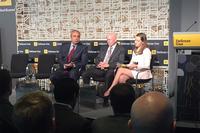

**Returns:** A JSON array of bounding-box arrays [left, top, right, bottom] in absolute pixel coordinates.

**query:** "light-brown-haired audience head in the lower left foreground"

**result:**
[[13, 91, 53, 133]]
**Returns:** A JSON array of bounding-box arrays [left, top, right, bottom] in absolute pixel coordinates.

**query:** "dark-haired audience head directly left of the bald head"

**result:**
[[110, 83, 135, 115]]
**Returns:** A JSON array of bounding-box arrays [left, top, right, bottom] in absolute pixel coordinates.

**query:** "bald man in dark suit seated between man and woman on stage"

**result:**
[[82, 33, 125, 105]]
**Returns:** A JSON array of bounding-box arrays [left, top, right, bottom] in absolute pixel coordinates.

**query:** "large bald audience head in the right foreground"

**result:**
[[129, 92, 174, 133]]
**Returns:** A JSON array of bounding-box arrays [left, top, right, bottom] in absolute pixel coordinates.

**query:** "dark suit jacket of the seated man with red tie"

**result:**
[[59, 42, 88, 70]]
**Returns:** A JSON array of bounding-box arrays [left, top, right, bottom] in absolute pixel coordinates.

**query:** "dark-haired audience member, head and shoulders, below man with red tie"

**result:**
[[53, 76, 91, 133]]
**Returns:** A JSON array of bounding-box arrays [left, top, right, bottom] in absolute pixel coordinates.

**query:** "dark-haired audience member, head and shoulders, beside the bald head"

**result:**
[[92, 83, 135, 133]]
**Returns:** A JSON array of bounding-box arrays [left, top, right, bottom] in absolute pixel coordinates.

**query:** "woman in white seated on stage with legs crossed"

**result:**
[[104, 33, 152, 96]]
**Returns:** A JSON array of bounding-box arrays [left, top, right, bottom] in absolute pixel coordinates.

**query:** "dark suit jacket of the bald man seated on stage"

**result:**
[[95, 44, 125, 69]]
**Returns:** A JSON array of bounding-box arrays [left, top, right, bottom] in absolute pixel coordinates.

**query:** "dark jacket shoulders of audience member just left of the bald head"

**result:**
[[91, 115, 131, 133]]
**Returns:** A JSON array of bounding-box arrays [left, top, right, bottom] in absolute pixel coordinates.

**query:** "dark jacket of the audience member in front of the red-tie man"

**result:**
[[54, 104, 91, 133]]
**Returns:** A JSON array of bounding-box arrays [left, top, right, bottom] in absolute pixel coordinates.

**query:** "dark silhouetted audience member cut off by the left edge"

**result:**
[[0, 69, 17, 133]]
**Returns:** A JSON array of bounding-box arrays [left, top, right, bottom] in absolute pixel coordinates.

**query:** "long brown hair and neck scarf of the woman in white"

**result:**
[[133, 33, 148, 55]]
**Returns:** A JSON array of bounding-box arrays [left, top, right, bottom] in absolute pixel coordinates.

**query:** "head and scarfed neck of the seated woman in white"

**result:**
[[135, 33, 148, 54]]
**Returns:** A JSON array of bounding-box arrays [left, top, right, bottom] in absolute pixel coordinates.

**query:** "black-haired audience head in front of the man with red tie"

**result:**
[[53, 76, 79, 108]]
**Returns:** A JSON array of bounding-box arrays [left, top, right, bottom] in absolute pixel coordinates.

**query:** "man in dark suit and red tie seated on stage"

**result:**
[[51, 30, 88, 80]]
